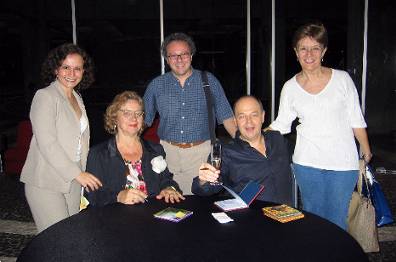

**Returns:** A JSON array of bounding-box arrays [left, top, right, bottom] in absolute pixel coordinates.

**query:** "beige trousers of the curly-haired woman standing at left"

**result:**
[[25, 180, 81, 233]]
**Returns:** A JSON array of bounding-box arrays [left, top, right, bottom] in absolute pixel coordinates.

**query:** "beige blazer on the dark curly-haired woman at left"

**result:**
[[20, 80, 89, 193]]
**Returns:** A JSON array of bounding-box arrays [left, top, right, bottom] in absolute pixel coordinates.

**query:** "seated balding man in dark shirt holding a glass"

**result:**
[[191, 96, 292, 205]]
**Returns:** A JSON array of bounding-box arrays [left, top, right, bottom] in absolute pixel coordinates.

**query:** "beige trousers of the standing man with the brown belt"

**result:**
[[160, 140, 210, 195]]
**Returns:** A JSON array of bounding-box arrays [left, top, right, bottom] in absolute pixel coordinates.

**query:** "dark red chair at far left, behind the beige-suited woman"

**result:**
[[4, 120, 33, 174]]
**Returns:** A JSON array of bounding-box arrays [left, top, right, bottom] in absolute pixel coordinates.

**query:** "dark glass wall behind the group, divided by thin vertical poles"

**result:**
[[0, 0, 396, 143]]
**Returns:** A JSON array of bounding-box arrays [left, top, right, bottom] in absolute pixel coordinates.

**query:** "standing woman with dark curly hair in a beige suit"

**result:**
[[21, 44, 102, 232]]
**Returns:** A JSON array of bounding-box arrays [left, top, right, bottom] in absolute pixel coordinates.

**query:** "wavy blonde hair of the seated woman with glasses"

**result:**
[[104, 91, 145, 135]]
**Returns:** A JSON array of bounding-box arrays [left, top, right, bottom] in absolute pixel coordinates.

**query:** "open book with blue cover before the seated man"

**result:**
[[214, 181, 264, 211]]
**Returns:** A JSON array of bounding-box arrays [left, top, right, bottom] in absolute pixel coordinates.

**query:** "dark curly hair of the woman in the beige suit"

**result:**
[[41, 43, 95, 90]]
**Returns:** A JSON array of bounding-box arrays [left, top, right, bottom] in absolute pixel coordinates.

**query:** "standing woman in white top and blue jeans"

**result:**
[[270, 23, 372, 229]]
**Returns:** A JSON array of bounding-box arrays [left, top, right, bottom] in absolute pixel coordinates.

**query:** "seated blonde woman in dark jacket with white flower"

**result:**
[[85, 91, 184, 206]]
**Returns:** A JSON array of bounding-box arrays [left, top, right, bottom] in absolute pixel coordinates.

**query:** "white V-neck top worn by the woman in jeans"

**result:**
[[271, 69, 367, 171]]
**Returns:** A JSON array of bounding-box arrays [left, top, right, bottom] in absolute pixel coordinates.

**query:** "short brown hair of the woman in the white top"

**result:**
[[292, 22, 328, 48]]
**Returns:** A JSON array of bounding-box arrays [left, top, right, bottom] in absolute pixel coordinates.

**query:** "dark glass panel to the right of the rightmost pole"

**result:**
[[366, 0, 396, 137]]
